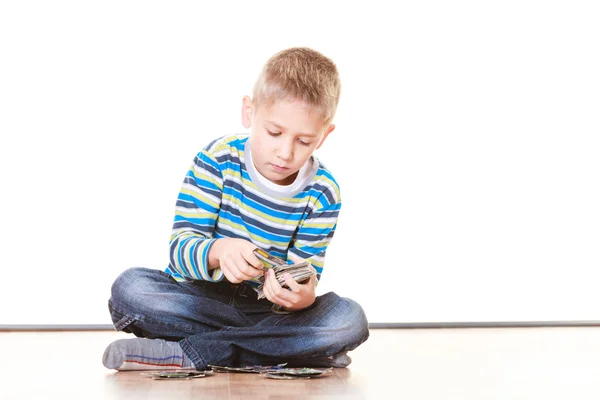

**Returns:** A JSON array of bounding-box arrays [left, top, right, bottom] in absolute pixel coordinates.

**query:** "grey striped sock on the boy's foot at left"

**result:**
[[102, 338, 194, 371]]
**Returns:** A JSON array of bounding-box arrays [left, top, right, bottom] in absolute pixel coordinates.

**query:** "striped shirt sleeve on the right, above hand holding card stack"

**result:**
[[288, 197, 342, 283]]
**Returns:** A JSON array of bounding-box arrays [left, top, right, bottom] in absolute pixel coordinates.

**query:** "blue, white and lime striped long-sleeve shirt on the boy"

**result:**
[[166, 135, 341, 282]]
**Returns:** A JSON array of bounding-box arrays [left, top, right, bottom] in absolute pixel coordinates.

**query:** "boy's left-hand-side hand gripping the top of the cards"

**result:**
[[208, 238, 264, 283]]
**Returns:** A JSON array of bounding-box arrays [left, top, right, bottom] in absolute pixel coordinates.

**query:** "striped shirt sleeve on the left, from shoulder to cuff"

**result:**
[[169, 150, 223, 282]]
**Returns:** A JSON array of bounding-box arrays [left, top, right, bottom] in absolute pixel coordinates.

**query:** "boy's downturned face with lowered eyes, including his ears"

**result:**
[[242, 97, 335, 185]]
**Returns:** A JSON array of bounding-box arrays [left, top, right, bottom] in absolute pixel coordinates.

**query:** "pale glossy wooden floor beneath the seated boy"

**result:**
[[0, 328, 600, 400]]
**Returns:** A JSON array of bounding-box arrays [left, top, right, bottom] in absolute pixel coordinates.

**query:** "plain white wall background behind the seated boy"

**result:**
[[0, 0, 600, 324]]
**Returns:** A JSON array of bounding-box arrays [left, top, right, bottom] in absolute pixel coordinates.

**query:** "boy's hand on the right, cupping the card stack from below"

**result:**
[[263, 255, 317, 311]]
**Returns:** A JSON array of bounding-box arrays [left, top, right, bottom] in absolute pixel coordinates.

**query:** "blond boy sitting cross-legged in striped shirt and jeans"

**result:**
[[103, 48, 369, 370]]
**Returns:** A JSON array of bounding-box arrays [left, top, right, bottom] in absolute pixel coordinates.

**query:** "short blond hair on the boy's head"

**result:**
[[252, 47, 341, 124]]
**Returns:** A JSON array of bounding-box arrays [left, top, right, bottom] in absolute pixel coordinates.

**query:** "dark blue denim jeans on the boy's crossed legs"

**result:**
[[108, 268, 369, 370]]
